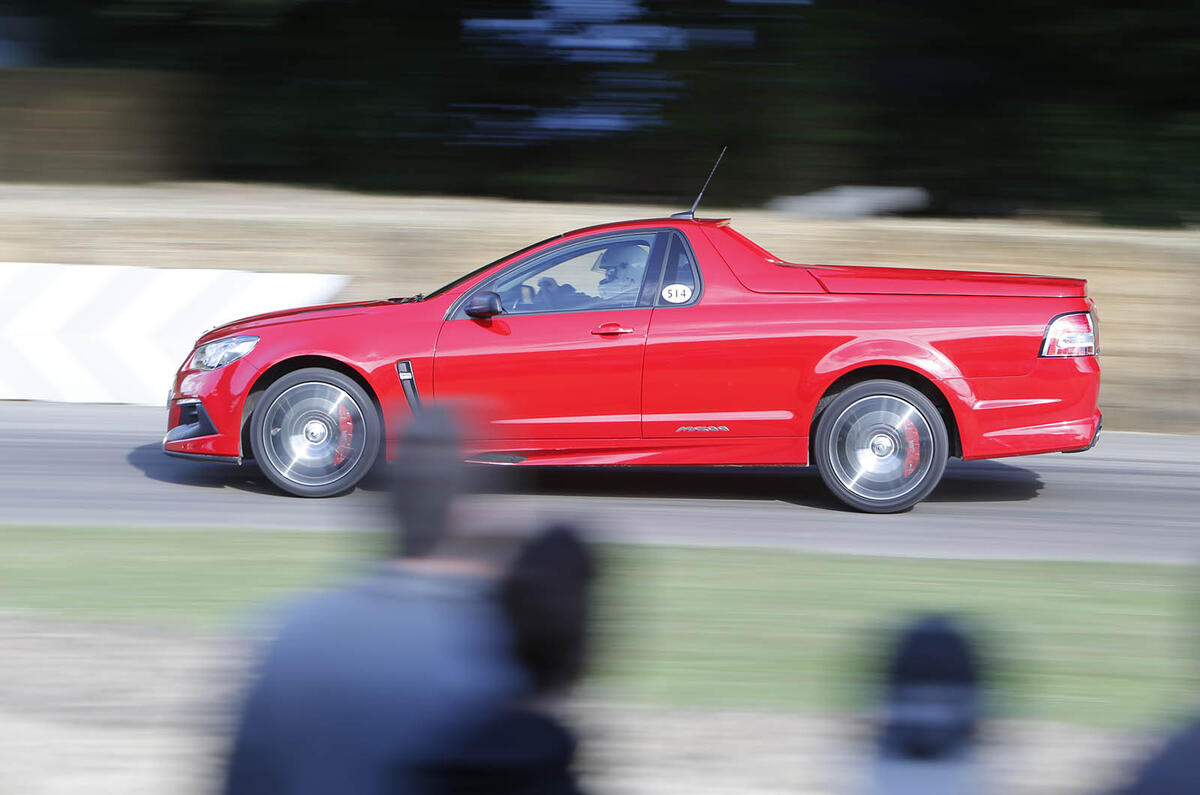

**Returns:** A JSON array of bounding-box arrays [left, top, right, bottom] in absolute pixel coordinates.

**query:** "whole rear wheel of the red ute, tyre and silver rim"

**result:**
[[812, 381, 950, 514]]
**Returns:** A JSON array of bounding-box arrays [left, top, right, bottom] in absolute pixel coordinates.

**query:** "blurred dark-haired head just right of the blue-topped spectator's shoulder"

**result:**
[[499, 525, 595, 694]]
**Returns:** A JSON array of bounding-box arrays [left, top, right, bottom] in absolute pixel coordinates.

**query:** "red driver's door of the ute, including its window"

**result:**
[[433, 229, 666, 442]]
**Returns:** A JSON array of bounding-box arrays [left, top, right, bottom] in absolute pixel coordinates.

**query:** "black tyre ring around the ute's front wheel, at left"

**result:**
[[250, 367, 383, 497]]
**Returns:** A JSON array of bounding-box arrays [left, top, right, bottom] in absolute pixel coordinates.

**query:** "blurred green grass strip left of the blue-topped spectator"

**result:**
[[0, 527, 377, 629]]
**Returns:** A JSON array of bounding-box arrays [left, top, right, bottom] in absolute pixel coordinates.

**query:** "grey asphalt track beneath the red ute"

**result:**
[[7, 401, 1200, 563]]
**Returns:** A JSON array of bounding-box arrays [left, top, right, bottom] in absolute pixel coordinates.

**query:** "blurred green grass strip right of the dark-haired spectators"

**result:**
[[592, 548, 1200, 725]]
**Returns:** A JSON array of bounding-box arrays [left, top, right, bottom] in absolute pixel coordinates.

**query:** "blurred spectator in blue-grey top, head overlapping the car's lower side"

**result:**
[[224, 407, 527, 795]]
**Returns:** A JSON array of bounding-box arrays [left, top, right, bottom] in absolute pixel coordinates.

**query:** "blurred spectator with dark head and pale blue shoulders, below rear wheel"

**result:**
[[866, 616, 985, 795]]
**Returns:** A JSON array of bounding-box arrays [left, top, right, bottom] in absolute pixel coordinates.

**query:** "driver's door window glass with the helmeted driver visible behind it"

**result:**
[[486, 232, 656, 315]]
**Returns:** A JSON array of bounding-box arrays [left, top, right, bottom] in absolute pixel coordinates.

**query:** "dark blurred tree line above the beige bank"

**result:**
[[0, 0, 1200, 227]]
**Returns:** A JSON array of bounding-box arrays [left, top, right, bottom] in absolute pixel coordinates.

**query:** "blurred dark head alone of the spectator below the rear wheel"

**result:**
[[881, 616, 983, 760]]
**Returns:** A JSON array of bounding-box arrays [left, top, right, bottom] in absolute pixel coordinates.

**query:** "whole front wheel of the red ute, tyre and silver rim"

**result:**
[[250, 367, 383, 497]]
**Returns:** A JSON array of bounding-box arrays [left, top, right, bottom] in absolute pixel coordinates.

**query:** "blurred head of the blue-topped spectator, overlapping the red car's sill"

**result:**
[[391, 406, 466, 557]]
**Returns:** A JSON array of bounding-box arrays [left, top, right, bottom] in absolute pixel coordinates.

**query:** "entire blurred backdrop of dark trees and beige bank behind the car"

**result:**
[[0, 0, 1200, 432]]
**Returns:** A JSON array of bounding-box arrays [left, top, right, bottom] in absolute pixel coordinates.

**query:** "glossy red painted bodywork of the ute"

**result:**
[[164, 219, 1099, 465]]
